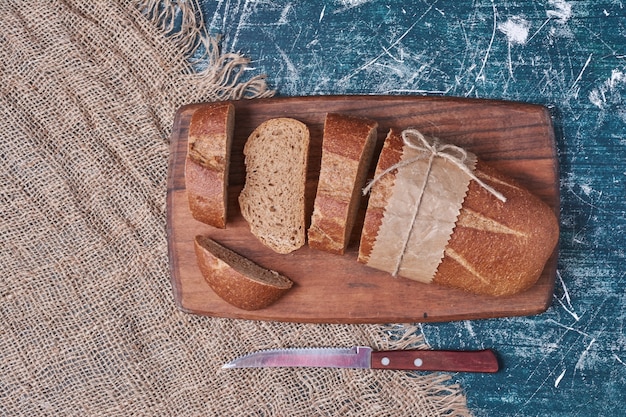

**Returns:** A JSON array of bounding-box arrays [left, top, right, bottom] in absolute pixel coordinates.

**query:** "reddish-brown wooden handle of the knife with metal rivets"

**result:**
[[372, 349, 498, 373]]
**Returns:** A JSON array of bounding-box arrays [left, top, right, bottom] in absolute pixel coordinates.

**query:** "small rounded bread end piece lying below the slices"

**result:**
[[194, 236, 293, 310]]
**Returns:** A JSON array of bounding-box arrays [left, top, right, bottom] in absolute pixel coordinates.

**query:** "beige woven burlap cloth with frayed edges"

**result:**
[[0, 0, 469, 416]]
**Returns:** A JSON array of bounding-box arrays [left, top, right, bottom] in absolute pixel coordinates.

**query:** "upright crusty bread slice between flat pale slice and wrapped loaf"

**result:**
[[308, 113, 378, 255]]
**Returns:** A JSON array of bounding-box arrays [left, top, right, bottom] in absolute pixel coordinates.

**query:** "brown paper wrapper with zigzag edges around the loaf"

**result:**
[[367, 133, 476, 283]]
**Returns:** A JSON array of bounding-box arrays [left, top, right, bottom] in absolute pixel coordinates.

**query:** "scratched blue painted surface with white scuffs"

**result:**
[[197, 0, 626, 416]]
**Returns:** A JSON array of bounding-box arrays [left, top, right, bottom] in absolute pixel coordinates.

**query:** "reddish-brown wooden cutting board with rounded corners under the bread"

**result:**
[[167, 96, 559, 323]]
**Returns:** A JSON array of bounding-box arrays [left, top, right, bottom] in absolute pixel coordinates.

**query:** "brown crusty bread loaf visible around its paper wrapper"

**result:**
[[359, 131, 559, 296]]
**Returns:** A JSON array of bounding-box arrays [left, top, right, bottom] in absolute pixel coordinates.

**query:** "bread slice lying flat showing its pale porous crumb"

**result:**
[[239, 118, 309, 254]]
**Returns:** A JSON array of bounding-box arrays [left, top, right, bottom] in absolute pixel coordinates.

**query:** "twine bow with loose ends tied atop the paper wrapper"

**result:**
[[363, 129, 506, 203]]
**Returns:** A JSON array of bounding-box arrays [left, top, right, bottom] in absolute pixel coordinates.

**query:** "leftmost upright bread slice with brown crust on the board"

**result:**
[[185, 102, 235, 228]]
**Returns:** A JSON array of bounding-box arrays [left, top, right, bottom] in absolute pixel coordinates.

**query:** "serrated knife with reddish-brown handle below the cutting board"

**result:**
[[222, 346, 498, 373]]
